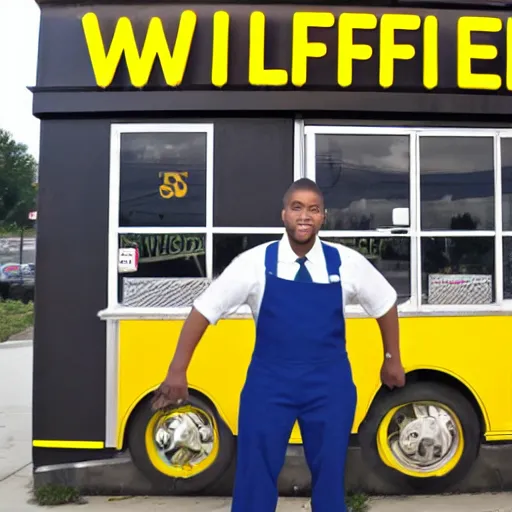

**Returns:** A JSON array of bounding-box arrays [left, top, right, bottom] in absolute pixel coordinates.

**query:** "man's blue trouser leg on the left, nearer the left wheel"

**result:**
[[231, 367, 297, 512]]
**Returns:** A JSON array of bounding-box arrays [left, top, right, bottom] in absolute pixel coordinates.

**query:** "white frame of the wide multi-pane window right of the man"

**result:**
[[304, 125, 512, 315]]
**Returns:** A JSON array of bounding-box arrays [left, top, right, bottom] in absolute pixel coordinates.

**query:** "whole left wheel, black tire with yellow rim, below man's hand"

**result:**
[[128, 396, 236, 494]]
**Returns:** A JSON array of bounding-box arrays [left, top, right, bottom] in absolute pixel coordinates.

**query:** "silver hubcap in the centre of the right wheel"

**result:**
[[388, 404, 461, 472]]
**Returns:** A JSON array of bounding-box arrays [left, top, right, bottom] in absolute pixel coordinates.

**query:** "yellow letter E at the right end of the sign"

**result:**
[[457, 16, 503, 91]]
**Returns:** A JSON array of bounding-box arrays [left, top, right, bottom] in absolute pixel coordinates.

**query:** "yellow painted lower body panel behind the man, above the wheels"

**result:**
[[118, 316, 512, 448]]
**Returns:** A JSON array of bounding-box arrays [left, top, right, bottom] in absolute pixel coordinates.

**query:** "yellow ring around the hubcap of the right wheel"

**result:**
[[377, 401, 464, 478]]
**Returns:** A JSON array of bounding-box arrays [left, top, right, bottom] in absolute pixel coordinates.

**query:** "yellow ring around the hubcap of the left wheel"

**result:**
[[144, 405, 219, 478]]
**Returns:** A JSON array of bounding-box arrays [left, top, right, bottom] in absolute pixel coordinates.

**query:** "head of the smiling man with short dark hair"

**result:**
[[281, 178, 325, 244]]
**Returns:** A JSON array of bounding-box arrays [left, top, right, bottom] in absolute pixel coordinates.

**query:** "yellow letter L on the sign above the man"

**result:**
[[249, 11, 288, 86]]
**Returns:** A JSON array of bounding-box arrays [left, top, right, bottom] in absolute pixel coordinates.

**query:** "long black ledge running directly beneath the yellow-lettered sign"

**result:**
[[33, 91, 512, 118]]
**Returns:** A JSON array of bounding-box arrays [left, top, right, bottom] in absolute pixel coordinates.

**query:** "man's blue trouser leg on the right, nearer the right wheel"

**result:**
[[298, 365, 356, 512]]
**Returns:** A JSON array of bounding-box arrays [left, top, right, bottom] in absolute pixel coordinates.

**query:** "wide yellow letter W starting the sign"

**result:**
[[82, 11, 197, 87]]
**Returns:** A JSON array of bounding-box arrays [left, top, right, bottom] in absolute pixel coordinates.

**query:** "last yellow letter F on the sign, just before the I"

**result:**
[[379, 14, 421, 87]]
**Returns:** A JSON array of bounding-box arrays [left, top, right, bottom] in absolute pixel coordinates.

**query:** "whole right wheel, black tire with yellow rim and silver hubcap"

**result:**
[[359, 382, 481, 492]]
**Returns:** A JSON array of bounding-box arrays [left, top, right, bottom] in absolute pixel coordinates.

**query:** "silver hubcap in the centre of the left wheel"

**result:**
[[153, 410, 215, 467]]
